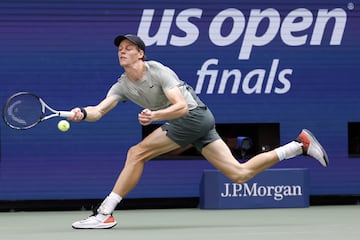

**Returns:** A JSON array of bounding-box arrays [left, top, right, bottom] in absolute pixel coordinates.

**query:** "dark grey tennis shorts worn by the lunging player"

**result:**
[[161, 107, 220, 152]]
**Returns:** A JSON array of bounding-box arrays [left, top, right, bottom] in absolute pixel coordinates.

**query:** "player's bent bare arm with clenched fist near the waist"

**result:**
[[138, 86, 189, 126]]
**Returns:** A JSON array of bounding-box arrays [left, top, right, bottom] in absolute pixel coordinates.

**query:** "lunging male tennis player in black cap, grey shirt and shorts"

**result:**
[[70, 35, 329, 229]]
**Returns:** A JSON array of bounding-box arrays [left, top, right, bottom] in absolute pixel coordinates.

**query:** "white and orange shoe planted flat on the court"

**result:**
[[72, 213, 117, 229]]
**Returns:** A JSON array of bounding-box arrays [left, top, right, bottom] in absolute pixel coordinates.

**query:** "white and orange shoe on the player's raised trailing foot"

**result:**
[[296, 129, 329, 167]]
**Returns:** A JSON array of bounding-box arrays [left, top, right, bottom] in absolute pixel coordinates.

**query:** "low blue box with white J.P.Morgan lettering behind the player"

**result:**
[[200, 169, 309, 209]]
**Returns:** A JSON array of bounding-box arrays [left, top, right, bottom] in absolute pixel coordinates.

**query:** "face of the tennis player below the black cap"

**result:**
[[118, 39, 144, 67]]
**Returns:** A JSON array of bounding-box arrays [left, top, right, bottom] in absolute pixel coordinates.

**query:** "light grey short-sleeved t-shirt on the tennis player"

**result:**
[[107, 61, 198, 110]]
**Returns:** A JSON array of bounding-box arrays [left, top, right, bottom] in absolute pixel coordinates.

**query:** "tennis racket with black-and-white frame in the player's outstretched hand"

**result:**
[[2, 92, 74, 130]]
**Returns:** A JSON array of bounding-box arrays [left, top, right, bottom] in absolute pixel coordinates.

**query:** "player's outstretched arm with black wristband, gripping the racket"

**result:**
[[68, 96, 119, 122]]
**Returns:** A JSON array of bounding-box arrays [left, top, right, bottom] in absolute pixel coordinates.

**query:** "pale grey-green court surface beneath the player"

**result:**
[[0, 205, 360, 240]]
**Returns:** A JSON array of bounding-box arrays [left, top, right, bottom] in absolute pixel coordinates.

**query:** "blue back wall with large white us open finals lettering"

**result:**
[[0, 0, 360, 200]]
